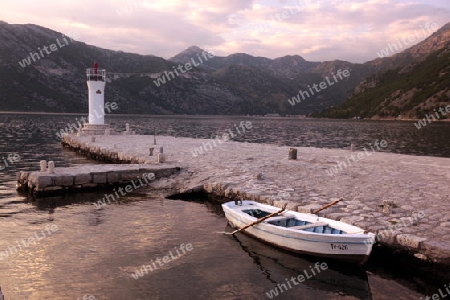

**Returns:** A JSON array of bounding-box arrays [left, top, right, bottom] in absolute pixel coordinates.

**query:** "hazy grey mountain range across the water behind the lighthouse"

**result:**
[[0, 22, 448, 115]]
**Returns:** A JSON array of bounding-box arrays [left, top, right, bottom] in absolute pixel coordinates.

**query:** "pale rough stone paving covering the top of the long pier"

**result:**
[[63, 135, 450, 264]]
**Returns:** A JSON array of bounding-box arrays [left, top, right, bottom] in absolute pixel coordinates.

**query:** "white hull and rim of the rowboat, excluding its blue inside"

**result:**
[[222, 201, 375, 264]]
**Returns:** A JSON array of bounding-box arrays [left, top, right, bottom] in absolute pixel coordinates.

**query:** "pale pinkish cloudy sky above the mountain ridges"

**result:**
[[0, 0, 450, 62]]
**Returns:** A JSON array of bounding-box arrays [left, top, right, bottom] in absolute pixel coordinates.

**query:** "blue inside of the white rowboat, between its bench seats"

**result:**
[[242, 209, 346, 234]]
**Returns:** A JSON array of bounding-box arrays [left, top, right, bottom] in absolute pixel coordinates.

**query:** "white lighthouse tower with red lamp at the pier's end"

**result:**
[[83, 63, 109, 135]]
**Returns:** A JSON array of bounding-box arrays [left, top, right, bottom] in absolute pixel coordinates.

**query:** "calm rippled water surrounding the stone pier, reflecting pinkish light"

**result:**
[[0, 115, 450, 300]]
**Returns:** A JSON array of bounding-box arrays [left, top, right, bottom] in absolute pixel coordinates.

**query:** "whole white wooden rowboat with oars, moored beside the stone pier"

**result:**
[[222, 200, 375, 264]]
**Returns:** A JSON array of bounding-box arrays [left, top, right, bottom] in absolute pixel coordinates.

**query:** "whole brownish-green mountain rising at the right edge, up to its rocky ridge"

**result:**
[[317, 24, 450, 119]]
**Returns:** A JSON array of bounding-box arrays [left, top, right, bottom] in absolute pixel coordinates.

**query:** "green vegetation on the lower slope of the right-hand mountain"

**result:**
[[316, 49, 450, 118]]
